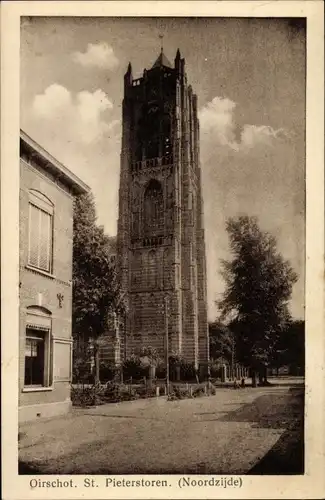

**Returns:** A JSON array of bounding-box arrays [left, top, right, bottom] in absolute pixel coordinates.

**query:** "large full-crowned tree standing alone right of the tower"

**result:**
[[217, 216, 297, 385]]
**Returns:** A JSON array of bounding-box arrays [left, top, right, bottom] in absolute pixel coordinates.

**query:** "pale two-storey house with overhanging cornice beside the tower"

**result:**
[[19, 131, 89, 421]]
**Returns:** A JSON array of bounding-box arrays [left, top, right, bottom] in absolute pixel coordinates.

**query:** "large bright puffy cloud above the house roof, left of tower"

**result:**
[[32, 83, 112, 144]]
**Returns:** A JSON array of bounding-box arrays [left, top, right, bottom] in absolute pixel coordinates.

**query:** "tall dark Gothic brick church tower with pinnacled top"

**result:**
[[117, 50, 209, 371]]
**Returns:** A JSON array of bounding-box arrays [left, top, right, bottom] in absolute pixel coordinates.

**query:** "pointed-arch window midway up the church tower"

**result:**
[[143, 179, 164, 236]]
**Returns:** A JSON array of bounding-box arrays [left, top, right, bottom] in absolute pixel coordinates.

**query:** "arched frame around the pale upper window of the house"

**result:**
[[27, 189, 54, 274]]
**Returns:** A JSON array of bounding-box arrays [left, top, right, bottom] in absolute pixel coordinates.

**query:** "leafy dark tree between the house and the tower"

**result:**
[[72, 193, 125, 381]]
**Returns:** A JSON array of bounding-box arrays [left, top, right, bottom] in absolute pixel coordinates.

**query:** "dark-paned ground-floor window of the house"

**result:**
[[25, 328, 49, 387]]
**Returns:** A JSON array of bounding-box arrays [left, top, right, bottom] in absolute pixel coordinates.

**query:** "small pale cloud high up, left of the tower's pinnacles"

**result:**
[[71, 42, 119, 69]]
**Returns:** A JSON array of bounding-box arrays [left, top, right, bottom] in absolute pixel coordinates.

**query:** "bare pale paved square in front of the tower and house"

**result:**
[[19, 385, 302, 474]]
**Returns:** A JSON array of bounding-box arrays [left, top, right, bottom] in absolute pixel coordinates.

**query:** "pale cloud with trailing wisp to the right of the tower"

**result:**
[[199, 97, 290, 151]]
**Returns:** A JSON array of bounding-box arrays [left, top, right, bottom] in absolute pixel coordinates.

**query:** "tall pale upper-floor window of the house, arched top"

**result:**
[[28, 191, 53, 272]]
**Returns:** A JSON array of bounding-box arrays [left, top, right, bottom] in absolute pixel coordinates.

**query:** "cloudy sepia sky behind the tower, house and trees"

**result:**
[[20, 17, 306, 320]]
